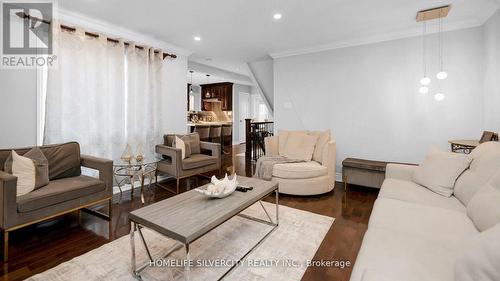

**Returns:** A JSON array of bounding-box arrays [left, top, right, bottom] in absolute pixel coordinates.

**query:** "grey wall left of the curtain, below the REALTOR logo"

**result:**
[[0, 69, 37, 149]]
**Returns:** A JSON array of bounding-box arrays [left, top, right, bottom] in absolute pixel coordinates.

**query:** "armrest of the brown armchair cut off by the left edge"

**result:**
[[0, 168, 17, 229]]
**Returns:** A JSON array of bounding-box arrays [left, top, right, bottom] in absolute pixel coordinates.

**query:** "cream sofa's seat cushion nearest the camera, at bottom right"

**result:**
[[350, 224, 463, 281]]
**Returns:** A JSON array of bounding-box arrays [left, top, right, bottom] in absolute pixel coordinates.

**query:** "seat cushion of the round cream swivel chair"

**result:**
[[273, 161, 328, 179]]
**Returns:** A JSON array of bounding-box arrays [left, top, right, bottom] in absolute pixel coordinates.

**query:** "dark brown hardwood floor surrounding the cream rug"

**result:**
[[1, 146, 378, 281]]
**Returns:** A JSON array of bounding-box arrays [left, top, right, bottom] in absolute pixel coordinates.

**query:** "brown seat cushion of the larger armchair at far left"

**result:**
[[17, 176, 106, 213]]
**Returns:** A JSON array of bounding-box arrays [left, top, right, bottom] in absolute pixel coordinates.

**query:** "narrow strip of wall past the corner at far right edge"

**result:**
[[484, 11, 500, 132]]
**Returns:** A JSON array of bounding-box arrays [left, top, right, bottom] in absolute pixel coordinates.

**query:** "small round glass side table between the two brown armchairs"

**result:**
[[113, 156, 160, 205]]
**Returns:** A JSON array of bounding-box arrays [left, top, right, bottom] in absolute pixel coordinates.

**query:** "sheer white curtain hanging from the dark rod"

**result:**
[[44, 29, 163, 159]]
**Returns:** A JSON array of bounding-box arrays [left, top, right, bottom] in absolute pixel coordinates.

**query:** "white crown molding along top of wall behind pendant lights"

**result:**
[[269, 17, 488, 59]]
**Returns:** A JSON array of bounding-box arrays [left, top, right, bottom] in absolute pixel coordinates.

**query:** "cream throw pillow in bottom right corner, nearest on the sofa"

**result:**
[[455, 224, 500, 281]]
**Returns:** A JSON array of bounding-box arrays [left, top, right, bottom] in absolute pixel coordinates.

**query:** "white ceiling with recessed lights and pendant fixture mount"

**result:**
[[59, 0, 500, 73]]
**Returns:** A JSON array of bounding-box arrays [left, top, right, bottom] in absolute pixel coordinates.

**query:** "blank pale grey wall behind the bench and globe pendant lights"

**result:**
[[274, 27, 484, 171]]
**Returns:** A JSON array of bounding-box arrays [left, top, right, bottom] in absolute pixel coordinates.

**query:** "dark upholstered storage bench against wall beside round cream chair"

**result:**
[[342, 158, 388, 190]]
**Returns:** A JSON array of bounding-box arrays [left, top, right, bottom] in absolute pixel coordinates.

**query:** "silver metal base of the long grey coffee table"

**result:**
[[130, 190, 279, 280]]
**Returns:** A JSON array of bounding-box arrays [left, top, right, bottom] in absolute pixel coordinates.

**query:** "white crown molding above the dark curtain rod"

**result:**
[[55, 7, 192, 57]]
